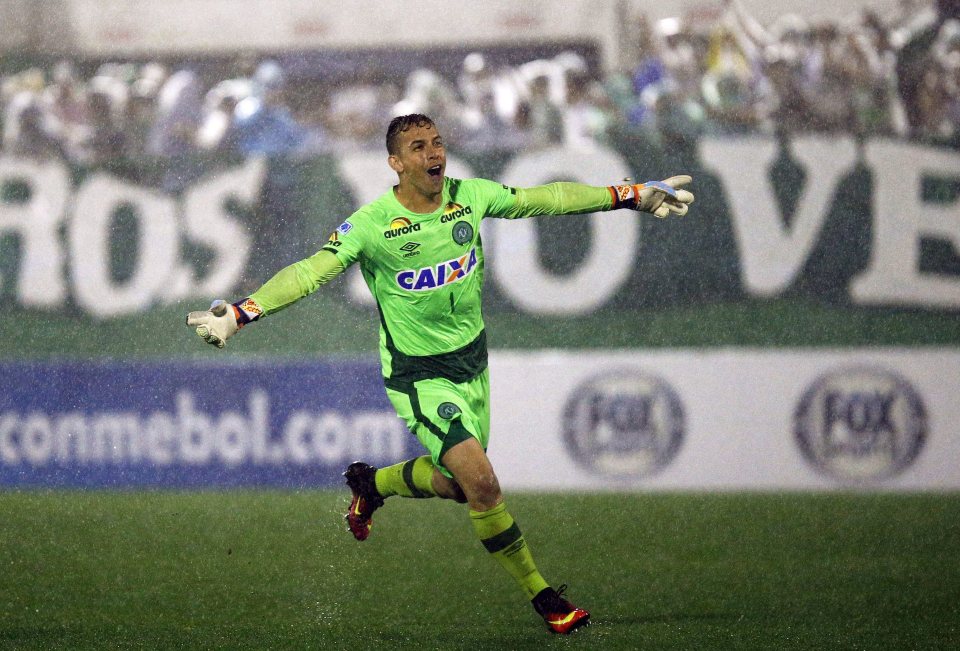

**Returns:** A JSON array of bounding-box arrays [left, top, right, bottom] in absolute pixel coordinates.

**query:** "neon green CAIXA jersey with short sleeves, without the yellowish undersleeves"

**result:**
[[323, 177, 516, 382]]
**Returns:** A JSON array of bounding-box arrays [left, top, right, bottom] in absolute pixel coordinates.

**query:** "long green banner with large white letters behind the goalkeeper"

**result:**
[[0, 135, 960, 357]]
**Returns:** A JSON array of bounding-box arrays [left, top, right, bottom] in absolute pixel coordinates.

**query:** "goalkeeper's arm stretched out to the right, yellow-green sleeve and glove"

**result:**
[[494, 175, 693, 219]]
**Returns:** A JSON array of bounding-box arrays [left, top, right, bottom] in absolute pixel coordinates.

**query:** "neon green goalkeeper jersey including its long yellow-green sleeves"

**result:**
[[250, 177, 614, 386]]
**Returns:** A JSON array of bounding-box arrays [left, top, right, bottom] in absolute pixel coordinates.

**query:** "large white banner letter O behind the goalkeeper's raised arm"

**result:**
[[496, 148, 640, 314]]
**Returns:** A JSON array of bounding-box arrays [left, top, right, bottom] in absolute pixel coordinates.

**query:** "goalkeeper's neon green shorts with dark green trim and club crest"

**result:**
[[387, 369, 490, 478]]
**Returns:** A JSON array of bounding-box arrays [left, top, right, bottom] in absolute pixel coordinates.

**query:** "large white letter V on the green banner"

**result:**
[[700, 138, 856, 296]]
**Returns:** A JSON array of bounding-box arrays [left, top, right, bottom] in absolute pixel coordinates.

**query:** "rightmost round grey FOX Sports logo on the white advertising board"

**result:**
[[794, 367, 927, 482]]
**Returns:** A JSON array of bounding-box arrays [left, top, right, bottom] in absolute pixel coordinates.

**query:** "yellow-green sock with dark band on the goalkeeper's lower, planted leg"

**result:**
[[470, 502, 548, 599]]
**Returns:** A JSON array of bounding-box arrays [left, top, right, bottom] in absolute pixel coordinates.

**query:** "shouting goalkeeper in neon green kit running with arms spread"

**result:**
[[187, 114, 693, 633]]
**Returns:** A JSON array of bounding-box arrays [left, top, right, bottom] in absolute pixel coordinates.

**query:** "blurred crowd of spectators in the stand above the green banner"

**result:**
[[0, 0, 960, 174]]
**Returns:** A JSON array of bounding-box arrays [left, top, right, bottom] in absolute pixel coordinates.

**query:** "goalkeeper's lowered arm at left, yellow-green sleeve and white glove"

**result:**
[[187, 250, 344, 348]]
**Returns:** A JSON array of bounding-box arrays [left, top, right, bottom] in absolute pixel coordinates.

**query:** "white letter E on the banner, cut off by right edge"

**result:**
[[850, 142, 960, 307]]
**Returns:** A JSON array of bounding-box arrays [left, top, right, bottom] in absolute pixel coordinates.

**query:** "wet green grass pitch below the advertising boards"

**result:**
[[0, 491, 960, 650]]
